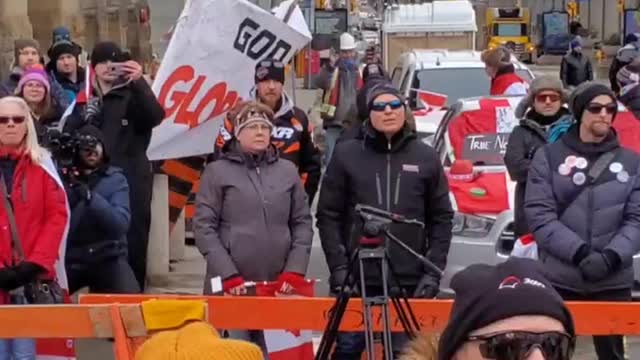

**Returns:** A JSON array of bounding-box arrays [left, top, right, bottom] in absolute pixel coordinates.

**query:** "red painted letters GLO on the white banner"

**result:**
[[158, 65, 240, 129]]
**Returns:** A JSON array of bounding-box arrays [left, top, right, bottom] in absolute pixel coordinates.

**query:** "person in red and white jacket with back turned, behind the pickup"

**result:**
[[481, 47, 529, 96]]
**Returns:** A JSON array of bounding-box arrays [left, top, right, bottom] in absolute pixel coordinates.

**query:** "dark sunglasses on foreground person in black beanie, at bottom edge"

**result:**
[[468, 331, 576, 360]]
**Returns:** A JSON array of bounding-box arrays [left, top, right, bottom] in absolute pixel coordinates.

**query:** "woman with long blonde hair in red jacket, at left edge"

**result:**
[[0, 96, 69, 359]]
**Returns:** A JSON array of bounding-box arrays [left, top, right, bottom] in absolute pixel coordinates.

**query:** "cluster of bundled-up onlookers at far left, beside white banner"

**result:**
[[0, 27, 164, 360]]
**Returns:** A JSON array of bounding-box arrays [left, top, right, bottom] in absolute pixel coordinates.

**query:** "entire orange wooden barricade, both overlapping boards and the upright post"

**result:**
[[0, 294, 640, 360]]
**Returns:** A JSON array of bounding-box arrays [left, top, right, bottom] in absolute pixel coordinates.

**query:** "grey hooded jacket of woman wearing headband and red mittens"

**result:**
[[193, 140, 313, 293]]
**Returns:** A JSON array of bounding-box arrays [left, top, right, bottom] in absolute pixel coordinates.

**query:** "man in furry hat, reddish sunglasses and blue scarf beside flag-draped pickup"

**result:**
[[504, 76, 573, 237]]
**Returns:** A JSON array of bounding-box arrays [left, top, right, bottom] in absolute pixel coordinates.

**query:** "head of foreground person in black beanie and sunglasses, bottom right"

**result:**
[[438, 258, 576, 360]]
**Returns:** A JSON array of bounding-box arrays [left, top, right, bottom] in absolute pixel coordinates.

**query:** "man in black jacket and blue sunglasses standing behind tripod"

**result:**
[[316, 86, 453, 359]]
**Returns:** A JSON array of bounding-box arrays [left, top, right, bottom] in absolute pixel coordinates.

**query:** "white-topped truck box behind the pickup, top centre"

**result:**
[[382, 0, 478, 71]]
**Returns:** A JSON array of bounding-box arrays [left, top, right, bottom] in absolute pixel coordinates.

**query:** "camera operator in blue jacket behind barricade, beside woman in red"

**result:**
[[64, 125, 140, 294]]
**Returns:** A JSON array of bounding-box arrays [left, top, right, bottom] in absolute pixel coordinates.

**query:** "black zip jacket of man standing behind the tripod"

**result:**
[[316, 122, 453, 287]]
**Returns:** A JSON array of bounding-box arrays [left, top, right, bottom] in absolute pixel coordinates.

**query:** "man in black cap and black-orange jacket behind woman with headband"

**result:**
[[214, 60, 322, 204]]
